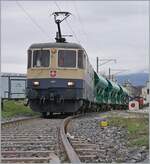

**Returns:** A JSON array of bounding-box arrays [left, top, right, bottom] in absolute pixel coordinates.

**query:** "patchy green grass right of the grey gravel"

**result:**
[[109, 117, 149, 148]]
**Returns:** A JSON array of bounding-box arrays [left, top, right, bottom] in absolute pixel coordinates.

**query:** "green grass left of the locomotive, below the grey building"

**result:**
[[1, 100, 38, 118]]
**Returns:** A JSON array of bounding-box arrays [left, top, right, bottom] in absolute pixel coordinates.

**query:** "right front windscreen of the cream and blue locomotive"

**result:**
[[58, 50, 76, 67]]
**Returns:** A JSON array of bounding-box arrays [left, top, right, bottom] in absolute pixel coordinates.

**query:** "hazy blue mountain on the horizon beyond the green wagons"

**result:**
[[117, 73, 149, 86]]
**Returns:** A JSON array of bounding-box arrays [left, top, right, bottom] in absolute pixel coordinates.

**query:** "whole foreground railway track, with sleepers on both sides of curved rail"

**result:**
[[1, 115, 102, 163]]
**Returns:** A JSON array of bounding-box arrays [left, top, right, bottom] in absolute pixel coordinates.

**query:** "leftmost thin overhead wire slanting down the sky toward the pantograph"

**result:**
[[16, 1, 48, 37]]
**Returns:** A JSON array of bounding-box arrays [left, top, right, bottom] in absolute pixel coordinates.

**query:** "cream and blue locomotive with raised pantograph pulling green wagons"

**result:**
[[27, 12, 128, 115]]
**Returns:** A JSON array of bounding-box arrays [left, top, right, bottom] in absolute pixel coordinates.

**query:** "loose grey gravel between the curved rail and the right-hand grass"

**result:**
[[68, 113, 148, 163]]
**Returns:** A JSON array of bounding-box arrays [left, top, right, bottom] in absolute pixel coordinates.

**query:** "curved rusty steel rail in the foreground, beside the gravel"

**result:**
[[60, 116, 81, 163]]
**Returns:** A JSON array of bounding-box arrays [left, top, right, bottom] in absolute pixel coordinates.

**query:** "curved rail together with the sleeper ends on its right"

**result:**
[[61, 115, 100, 163]]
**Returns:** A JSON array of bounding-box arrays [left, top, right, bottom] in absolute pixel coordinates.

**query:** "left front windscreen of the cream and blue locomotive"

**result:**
[[33, 50, 50, 67]]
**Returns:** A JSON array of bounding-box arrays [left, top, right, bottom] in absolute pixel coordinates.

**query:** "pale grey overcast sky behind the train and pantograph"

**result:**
[[1, 1, 149, 73]]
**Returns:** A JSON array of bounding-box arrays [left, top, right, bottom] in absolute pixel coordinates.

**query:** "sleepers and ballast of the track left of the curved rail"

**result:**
[[1, 118, 65, 163]]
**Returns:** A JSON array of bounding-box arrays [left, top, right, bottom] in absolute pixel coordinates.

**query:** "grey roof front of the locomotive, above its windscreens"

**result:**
[[29, 42, 83, 49]]
